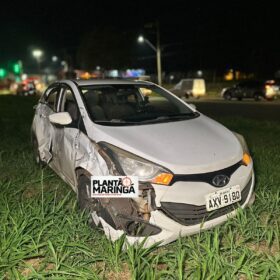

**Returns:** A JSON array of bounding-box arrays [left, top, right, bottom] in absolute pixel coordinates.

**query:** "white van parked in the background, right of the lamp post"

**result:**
[[170, 79, 206, 98]]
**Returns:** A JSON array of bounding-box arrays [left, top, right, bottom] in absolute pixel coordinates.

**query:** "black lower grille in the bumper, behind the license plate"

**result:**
[[160, 178, 252, 226]]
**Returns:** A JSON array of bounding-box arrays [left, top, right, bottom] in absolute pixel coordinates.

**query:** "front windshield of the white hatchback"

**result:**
[[80, 84, 198, 125]]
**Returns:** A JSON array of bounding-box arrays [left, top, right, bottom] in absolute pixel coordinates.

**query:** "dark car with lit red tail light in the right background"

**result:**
[[221, 80, 267, 101]]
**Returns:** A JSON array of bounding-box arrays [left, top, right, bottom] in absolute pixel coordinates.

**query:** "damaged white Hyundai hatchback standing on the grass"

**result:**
[[32, 80, 255, 245]]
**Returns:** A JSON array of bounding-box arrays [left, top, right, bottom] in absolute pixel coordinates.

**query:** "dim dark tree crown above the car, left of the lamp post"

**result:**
[[77, 27, 133, 69]]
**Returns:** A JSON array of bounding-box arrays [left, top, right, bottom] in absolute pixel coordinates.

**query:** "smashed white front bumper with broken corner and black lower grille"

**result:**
[[77, 142, 255, 246]]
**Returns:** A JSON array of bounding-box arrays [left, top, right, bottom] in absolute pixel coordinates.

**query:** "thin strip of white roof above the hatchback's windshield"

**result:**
[[60, 79, 153, 86]]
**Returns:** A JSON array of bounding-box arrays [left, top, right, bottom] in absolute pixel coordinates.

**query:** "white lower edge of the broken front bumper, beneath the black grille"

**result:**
[[100, 172, 255, 247]]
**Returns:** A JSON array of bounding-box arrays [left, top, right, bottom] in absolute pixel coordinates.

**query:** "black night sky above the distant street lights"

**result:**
[[0, 1, 280, 76]]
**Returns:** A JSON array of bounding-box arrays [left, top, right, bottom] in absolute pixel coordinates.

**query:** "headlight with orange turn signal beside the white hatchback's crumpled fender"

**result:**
[[99, 142, 173, 185]]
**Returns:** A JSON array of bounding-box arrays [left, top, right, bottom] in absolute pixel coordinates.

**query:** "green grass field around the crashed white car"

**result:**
[[0, 96, 280, 279]]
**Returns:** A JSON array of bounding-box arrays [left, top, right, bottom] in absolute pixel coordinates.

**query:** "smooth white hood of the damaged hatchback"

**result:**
[[89, 115, 243, 174]]
